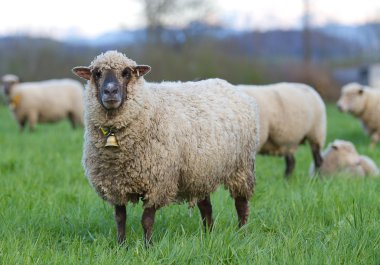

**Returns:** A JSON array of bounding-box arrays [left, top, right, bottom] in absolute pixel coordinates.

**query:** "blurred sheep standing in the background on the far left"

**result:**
[[3, 75, 83, 131]]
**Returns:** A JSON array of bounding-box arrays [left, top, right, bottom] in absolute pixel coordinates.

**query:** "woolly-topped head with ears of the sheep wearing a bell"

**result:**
[[73, 51, 150, 110]]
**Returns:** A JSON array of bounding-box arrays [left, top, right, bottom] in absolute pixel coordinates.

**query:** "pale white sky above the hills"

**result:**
[[0, 0, 380, 39]]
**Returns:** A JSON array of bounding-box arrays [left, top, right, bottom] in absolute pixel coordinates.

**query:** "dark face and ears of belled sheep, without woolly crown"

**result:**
[[73, 65, 150, 110]]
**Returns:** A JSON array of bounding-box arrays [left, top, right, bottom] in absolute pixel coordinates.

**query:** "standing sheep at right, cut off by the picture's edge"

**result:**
[[337, 83, 380, 149]]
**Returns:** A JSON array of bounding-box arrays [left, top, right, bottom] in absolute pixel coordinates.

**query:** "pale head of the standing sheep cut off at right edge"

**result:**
[[337, 83, 366, 115]]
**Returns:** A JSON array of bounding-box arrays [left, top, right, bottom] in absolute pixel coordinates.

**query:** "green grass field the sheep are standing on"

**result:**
[[0, 106, 380, 264]]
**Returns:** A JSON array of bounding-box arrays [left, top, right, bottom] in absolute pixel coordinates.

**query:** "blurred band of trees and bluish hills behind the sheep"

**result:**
[[0, 0, 380, 100]]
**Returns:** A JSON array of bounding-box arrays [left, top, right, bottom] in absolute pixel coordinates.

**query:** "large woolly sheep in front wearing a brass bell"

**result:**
[[73, 51, 259, 246]]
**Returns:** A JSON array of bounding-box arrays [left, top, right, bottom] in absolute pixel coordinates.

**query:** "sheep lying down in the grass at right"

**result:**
[[310, 139, 379, 177]]
